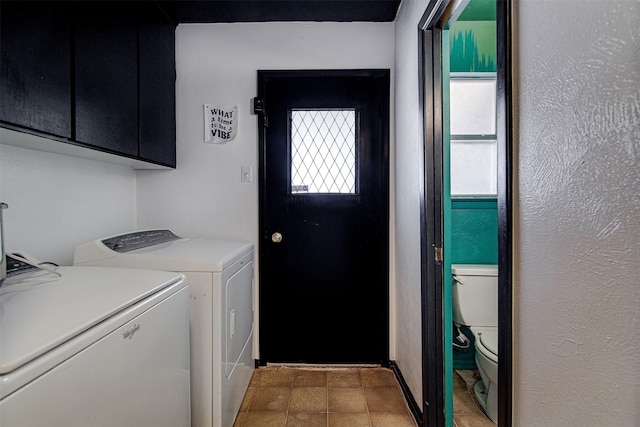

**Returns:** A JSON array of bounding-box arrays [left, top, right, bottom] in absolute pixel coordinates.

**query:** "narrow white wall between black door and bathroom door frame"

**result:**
[[392, 0, 428, 410]]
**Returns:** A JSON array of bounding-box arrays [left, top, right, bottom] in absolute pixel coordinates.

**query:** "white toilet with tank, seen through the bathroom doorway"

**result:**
[[451, 264, 498, 424]]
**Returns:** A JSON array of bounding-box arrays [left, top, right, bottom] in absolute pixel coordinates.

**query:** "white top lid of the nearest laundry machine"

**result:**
[[0, 267, 184, 375]]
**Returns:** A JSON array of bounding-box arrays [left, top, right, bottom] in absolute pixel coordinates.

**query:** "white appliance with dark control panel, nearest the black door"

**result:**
[[74, 230, 255, 427]]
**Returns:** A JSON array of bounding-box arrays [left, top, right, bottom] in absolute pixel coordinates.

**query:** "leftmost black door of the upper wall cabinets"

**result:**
[[0, 1, 71, 138]]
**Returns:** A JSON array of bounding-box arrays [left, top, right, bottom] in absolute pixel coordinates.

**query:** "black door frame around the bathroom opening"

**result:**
[[418, 0, 513, 427]]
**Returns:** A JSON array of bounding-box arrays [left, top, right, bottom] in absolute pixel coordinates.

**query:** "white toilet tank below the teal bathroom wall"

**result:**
[[451, 264, 498, 326]]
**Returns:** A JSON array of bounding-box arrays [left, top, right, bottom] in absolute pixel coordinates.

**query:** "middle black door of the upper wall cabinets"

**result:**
[[74, 2, 138, 157]]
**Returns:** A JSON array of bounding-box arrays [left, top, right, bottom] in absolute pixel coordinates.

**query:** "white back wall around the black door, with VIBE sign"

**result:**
[[138, 23, 394, 358]]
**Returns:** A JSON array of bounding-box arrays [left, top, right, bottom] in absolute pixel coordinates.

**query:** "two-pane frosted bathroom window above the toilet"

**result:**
[[450, 73, 498, 197]]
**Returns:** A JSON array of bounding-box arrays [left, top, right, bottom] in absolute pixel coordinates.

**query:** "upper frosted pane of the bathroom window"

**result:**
[[450, 78, 496, 135]]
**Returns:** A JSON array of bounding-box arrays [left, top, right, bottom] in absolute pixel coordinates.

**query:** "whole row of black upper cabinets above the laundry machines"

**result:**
[[0, 1, 176, 167]]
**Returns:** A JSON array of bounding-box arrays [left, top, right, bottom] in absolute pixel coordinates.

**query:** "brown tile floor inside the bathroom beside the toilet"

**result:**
[[453, 370, 496, 427]]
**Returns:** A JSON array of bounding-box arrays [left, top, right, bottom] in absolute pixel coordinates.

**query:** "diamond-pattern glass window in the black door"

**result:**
[[291, 109, 357, 194]]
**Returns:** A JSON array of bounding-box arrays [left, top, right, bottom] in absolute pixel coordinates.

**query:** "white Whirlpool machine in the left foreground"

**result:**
[[0, 267, 190, 427]]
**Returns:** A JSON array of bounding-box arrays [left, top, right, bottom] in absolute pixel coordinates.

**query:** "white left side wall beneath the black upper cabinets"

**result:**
[[0, 144, 136, 265]]
